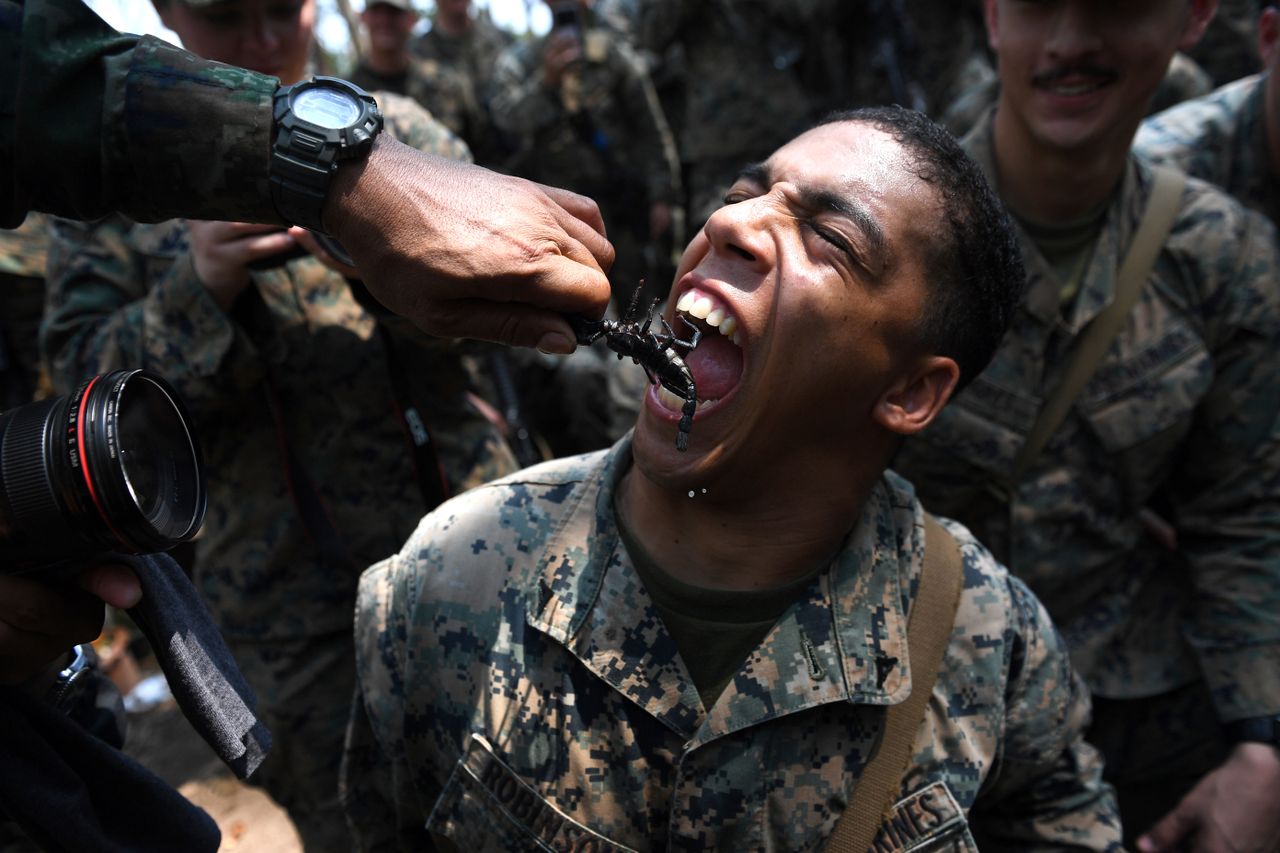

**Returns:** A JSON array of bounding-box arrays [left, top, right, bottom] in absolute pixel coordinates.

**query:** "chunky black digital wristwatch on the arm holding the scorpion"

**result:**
[[270, 77, 383, 233]]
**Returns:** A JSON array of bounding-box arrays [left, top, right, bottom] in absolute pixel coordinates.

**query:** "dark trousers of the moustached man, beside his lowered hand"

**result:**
[[1087, 681, 1228, 849]]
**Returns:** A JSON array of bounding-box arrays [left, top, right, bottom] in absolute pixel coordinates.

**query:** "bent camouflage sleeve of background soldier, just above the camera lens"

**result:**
[[40, 216, 261, 415]]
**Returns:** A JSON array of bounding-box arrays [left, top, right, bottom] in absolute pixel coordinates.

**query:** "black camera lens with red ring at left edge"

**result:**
[[0, 370, 205, 573]]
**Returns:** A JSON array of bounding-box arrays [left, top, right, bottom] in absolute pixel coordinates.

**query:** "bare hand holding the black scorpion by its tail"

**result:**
[[325, 134, 613, 353]]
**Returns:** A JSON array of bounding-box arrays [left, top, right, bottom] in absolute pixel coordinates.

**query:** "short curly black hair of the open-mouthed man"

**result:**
[[817, 106, 1027, 391]]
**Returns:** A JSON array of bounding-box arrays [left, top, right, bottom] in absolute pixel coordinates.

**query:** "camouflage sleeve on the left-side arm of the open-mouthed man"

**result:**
[[342, 540, 436, 850]]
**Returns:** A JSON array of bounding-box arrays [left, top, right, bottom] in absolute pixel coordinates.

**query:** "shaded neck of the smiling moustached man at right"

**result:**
[[995, 104, 1133, 222]]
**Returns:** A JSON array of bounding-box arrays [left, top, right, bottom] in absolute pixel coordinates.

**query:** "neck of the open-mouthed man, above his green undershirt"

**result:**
[[617, 448, 878, 589]]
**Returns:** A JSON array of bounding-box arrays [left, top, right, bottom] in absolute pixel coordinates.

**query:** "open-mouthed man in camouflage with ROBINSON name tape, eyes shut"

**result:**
[[344, 109, 1119, 850]]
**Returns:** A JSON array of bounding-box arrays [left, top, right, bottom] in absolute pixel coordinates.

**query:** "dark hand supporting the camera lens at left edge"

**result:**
[[0, 565, 142, 685]]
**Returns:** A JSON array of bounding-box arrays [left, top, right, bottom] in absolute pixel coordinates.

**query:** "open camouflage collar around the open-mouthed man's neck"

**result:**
[[527, 435, 923, 748]]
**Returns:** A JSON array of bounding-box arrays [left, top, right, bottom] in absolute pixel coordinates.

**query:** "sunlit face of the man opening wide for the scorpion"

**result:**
[[634, 122, 941, 489]]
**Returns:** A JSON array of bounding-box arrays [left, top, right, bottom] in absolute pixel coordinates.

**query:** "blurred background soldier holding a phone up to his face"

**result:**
[[490, 0, 678, 306]]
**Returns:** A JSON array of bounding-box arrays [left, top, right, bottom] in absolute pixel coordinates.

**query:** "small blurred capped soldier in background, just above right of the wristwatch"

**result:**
[[349, 0, 488, 147]]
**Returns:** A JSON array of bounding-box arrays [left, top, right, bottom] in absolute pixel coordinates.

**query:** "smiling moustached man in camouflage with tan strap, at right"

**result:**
[[893, 0, 1280, 853]]
